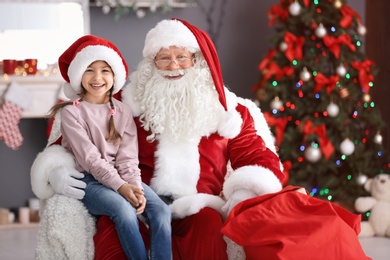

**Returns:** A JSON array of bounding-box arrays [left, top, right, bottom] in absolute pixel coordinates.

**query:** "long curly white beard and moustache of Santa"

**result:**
[[133, 61, 224, 142]]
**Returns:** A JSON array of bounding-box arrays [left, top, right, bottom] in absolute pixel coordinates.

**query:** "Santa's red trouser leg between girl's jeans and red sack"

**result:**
[[172, 208, 228, 260]]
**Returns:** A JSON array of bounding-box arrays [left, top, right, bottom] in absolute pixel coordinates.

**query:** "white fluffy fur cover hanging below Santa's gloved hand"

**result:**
[[35, 195, 96, 260]]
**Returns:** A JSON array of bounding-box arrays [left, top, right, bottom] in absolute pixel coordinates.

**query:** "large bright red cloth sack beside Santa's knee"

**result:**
[[222, 186, 371, 260]]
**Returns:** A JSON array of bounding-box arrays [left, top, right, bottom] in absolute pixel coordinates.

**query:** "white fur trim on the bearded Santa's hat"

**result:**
[[142, 20, 200, 58]]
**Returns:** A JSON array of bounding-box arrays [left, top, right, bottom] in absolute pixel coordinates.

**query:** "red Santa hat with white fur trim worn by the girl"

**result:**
[[58, 35, 128, 100]]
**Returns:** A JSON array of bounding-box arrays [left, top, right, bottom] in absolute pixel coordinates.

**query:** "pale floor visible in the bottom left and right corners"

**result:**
[[0, 224, 390, 260]]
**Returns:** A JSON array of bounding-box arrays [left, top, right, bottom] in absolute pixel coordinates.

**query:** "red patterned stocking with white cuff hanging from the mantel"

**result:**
[[0, 83, 31, 150]]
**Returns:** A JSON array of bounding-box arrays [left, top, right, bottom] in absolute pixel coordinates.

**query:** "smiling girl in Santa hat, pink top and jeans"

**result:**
[[51, 35, 171, 260]]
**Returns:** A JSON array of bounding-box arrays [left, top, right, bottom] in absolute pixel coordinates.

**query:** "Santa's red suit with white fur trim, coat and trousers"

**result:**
[[94, 90, 283, 259]]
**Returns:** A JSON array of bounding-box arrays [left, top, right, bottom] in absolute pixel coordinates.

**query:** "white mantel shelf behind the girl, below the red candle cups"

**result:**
[[0, 74, 64, 118]]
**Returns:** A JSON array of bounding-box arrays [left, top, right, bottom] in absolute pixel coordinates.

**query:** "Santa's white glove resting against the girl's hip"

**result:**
[[49, 166, 87, 199]]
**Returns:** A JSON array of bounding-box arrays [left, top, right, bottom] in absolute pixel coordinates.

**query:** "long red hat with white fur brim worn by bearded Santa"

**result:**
[[143, 18, 227, 110]]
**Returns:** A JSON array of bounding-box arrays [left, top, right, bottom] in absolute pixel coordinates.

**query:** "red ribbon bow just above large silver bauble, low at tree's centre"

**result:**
[[303, 120, 334, 159]]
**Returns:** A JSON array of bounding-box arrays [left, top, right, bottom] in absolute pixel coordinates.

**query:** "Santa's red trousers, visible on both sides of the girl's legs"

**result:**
[[94, 208, 228, 260]]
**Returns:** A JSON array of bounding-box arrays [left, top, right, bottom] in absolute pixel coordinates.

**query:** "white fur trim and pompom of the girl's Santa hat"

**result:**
[[64, 45, 127, 98]]
